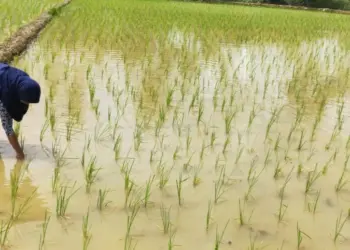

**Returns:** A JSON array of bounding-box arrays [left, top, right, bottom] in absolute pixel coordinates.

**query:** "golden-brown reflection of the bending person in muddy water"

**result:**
[[0, 160, 46, 222]]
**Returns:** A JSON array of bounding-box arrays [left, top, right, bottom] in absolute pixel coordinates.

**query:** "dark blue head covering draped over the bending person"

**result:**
[[0, 63, 41, 122]]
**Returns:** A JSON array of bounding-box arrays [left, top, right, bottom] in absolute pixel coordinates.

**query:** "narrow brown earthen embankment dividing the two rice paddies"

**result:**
[[0, 0, 72, 63]]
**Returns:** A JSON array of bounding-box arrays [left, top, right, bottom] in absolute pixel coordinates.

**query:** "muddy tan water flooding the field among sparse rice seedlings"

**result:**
[[0, 19, 350, 250]]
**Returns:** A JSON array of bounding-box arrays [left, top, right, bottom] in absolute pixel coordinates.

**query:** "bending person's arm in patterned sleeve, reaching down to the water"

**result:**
[[0, 104, 24, 160]]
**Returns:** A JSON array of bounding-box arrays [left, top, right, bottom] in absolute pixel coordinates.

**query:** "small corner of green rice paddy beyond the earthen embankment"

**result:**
[[0, 0, 61, 43]]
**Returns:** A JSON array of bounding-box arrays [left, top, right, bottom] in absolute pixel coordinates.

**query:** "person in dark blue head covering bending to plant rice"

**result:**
[[0, 63, 41, 160]]
